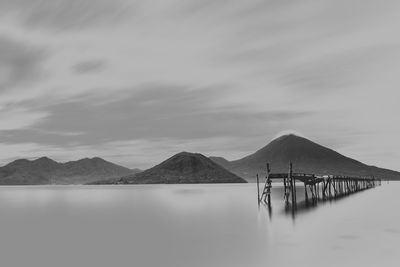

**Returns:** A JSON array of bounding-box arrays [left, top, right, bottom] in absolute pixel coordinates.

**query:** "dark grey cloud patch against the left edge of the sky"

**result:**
[[0, 36, 46, 92]]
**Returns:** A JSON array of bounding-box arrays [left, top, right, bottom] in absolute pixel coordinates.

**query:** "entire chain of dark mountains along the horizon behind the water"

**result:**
[[0, 134, 400, 185]]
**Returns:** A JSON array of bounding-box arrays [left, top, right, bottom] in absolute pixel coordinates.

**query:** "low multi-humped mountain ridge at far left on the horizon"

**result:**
[[0, 157, 135, 185]]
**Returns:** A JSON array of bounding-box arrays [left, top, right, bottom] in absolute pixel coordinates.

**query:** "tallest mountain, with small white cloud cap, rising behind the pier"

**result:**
[[212, 134, 400, 181]]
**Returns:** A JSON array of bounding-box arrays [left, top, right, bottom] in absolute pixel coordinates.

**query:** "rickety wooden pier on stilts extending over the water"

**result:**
[[257, 163, 381, 207]]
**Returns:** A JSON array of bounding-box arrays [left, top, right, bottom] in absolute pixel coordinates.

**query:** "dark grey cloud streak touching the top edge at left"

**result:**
[[0, 0, 130, 30]]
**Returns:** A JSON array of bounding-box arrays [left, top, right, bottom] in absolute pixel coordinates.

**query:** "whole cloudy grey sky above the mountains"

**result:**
[[0, 0, 400, 170]]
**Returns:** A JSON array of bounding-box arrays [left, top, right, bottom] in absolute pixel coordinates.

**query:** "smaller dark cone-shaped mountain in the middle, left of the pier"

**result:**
[[93, 152, 246, 184]]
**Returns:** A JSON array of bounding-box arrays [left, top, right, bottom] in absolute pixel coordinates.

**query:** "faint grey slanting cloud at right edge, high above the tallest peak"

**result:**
[[277, 44, 400, 93]]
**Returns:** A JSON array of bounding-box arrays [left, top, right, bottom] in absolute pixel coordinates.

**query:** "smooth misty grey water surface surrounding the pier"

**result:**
[[0, 182, 400, 267]]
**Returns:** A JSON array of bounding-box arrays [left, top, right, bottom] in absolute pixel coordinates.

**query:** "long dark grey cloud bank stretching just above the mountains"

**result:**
[[2, 85, 311, 148]]
